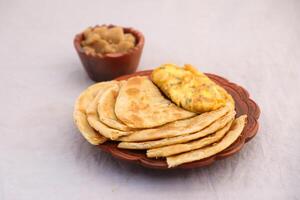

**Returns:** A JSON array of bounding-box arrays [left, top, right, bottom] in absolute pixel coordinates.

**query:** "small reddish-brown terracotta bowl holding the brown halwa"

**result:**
[[74, 25, 145, 82]]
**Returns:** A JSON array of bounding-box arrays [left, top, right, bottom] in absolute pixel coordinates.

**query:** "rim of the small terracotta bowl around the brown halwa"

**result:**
[[73, 24, 145, 59]]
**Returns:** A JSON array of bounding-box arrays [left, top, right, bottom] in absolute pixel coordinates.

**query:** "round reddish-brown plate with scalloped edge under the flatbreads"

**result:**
[[99, 70, 260, 169]]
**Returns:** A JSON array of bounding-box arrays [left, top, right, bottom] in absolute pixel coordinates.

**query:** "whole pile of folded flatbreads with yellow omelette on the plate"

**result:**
[[74, 65, 246, 167]]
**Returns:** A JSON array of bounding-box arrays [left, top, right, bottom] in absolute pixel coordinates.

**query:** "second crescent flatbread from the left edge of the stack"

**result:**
[[86, 83, 130, 140]]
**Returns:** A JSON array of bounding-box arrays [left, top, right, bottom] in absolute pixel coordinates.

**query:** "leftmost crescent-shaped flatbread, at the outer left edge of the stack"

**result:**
[[73, 82, 116, 145]]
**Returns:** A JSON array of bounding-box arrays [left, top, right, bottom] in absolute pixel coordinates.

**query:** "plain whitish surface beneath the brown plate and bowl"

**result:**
[[0, 0, 300, 200]]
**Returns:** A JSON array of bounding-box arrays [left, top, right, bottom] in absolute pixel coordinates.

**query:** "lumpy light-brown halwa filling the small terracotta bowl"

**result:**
[[81, 26, 136, 54]]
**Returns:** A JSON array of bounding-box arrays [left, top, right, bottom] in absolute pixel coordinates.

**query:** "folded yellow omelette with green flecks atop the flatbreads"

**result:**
[[151, 64, 233, 113]]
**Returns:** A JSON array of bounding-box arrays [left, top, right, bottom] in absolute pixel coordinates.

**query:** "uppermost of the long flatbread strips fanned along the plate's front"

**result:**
[[118, 105, 232, 142]]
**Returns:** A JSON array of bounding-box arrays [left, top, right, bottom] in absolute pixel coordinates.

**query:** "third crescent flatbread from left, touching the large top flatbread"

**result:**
[[98, 84, 132, 131]]
